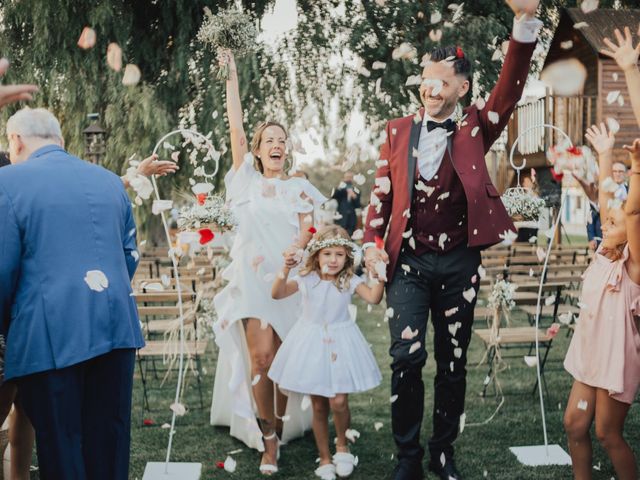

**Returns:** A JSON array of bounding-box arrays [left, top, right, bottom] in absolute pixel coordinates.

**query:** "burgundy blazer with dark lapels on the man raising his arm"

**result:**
[[364, 39, 536, 281]]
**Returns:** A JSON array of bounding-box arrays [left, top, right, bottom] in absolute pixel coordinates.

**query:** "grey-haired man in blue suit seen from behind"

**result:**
[[0, 109, 144, 480]]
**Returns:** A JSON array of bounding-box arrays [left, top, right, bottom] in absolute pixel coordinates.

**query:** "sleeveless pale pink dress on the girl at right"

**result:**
[[564, 246, 640, 403]]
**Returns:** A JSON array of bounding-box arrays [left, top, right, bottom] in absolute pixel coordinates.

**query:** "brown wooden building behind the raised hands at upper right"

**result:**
[[497, 8, 640, 188]]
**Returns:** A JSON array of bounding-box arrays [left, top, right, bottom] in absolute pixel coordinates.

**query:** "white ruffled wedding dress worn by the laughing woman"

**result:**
[[211, 158, 326, 451]]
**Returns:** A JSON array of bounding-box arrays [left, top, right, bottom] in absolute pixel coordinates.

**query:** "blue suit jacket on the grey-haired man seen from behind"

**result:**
[[0, 145, 144, 379]]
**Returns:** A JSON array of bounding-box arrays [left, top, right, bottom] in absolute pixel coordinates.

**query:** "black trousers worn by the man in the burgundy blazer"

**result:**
[[387, 245, 480, 463]]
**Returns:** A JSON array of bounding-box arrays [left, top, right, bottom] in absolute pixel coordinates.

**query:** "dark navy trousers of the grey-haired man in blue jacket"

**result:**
[[16, 349, 135, 480]]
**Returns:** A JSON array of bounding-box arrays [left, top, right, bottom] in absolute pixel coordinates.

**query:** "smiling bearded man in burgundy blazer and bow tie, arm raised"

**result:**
[[364, 0, 541, 480]]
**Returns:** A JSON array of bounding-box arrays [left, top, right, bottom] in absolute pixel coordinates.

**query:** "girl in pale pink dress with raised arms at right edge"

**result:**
[[564, 124, 640, 480]]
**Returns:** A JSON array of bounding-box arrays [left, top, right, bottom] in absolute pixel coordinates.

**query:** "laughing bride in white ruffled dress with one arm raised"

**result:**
[[211, 52, 326, 475]]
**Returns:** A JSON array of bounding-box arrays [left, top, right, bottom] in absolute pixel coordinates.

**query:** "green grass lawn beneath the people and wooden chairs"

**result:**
[[130, 304, 640, 480]]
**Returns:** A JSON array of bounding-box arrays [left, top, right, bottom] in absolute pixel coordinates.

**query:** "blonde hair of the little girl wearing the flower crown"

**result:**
[[300, 225, 355, 291]]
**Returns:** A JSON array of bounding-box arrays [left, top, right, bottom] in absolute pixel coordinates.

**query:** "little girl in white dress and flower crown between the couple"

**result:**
[[269, 225, 384, 480]]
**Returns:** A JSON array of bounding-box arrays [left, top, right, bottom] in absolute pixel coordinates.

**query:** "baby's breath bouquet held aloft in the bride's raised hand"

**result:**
[[197, 7, 258, 80]]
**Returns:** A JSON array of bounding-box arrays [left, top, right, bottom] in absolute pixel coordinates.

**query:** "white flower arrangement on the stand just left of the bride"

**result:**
[[178, 194, 236, 232]]
